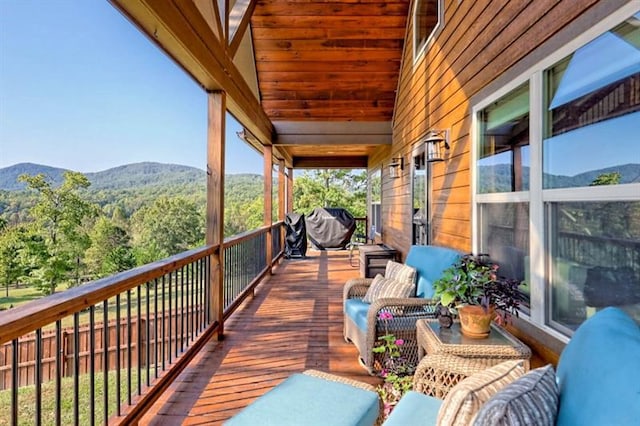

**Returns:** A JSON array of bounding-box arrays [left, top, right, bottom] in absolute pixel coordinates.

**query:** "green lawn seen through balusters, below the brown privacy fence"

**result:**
[[0, 369, 154, 425]]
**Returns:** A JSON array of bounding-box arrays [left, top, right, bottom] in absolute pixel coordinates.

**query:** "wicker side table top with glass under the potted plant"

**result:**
[[416, 319, 531, 370]]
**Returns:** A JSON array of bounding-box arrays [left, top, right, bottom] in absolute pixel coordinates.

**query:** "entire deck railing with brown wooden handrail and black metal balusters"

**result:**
[[0, 222, 282, 425]]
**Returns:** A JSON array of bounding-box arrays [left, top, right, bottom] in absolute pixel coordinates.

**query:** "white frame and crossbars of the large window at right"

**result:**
[[471, 3, 640, 342]]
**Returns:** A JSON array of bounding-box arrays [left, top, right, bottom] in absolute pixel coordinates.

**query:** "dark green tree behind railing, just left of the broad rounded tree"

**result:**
[[85, 216, 136, 277]]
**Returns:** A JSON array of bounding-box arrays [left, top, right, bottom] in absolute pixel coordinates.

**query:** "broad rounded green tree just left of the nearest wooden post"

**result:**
[[131, 197, 204, 264]]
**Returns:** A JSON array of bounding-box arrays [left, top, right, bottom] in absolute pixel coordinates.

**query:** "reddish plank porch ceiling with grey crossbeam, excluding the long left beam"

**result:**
[[251, 0, 409, 167]]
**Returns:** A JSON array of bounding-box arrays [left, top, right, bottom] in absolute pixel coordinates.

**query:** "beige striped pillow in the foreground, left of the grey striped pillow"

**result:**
[[438, 360, 524, 426]]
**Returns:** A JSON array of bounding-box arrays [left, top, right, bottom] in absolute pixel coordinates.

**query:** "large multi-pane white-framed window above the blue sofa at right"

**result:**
[[474, 5, 640, 335]]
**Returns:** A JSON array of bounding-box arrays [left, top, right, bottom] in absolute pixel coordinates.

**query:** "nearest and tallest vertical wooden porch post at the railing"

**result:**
[[205, 92, 227, 337]]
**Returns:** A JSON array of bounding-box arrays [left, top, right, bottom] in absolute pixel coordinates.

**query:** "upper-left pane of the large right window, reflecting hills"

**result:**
[[477, 84, 530, 194]]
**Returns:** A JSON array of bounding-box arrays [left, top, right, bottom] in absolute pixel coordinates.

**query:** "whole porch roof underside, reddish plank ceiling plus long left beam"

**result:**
[[110, 0, 410, 167]]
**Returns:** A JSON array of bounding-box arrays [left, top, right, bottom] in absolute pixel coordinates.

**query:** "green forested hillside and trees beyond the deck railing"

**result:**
[[0, 163, 366, 297]]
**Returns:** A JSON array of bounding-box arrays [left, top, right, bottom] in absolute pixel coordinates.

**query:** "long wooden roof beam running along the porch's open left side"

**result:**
[[110, 0, 273, 144]]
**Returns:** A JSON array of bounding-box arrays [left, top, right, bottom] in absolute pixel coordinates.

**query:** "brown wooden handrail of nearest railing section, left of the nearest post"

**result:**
[[0, 245, 219, 345]]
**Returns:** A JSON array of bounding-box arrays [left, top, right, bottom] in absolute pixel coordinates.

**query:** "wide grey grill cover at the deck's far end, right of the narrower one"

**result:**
[[306, 208, 356, 250]]
